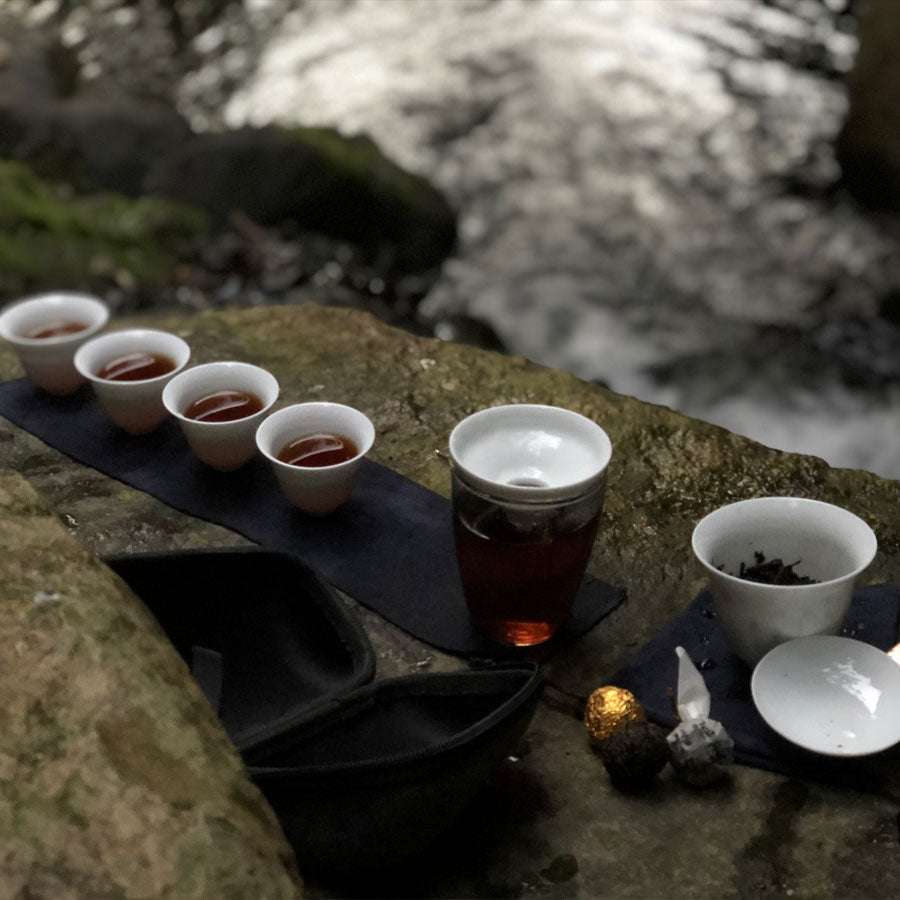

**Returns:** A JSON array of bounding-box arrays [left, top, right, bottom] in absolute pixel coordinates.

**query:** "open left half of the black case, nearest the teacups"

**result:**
[[105, 547, 375, 750]]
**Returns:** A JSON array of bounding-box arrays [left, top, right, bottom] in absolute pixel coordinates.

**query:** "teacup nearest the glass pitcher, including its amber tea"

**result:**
[[256, 402, 375, 516]]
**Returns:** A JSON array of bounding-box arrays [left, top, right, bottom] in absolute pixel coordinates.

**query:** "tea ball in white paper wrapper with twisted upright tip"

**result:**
[[666, 647, 734, 785]]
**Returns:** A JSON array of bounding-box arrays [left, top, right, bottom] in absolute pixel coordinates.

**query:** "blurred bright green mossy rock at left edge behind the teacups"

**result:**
[[0, 161, 209, 301]]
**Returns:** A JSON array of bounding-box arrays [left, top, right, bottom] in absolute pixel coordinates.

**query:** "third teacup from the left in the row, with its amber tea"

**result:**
[[162, 362, 278, 472]]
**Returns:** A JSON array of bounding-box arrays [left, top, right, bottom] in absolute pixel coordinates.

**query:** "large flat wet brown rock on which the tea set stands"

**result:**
[[0, 307, 900, 897]]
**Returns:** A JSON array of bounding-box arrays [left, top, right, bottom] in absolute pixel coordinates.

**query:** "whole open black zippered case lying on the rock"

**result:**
[[105, 547, 541, 871]]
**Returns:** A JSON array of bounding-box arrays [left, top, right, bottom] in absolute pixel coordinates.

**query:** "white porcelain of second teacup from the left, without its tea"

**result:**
[[75, 328, 191, 434]]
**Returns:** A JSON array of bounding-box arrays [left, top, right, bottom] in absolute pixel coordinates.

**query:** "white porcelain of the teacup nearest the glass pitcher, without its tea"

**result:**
[[256, 402, 375, 516]]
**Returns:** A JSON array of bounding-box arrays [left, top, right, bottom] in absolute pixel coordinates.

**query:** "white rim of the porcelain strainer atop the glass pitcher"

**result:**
[[447, 403, 613, 503]]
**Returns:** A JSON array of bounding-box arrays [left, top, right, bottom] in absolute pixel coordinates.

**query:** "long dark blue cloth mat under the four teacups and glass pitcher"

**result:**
[[0, 378, 625, 658]]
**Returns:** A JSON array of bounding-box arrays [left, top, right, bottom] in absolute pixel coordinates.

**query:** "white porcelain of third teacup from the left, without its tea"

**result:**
[[162, 362, 278, 472]]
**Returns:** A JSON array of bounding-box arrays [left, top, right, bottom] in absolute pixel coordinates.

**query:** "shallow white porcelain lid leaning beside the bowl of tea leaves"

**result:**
[[750, 635, 900, 756]]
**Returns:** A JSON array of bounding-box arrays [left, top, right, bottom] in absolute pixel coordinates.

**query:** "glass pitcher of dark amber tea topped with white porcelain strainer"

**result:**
[[450, 404, 612, 646]]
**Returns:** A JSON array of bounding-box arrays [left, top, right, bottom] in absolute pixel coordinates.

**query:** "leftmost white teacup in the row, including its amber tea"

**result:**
[[0, 293, 109, 396]]
